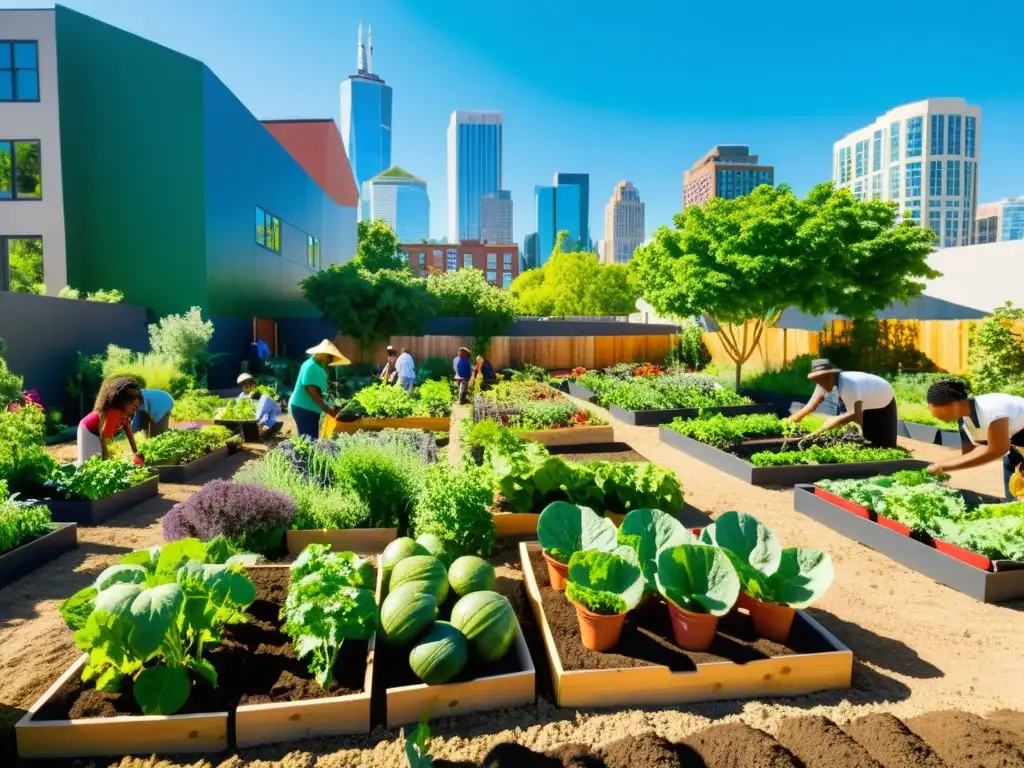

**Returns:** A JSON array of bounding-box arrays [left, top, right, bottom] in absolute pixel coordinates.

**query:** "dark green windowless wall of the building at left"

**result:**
[[57, 6, 208, 316]]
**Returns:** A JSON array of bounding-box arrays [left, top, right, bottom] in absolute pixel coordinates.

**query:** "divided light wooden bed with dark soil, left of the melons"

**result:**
[[15, 566, 375, 758]]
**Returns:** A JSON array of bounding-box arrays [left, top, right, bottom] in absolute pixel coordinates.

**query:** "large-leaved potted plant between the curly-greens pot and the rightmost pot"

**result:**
[[654, 544, 739, 651]]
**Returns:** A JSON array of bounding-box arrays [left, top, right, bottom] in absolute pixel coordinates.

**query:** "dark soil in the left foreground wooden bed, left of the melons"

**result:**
[[36, 568, 367, 720]]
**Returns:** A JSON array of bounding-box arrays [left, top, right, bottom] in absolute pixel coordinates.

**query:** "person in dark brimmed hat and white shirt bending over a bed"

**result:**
[[790, 359, 898, 447]]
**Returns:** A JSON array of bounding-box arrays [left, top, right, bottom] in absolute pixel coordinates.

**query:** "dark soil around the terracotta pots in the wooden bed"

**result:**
[[529, 552, 831, 672]]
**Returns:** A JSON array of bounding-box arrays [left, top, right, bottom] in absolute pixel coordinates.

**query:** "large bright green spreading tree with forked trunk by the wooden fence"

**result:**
[[631, 183, 938, 386]]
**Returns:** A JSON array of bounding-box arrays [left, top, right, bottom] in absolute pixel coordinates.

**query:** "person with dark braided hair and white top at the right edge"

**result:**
[[928, 379, 1024, 501]]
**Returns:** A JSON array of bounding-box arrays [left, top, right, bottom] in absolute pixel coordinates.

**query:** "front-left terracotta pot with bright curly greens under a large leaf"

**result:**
[[565, 547, 644, 651]]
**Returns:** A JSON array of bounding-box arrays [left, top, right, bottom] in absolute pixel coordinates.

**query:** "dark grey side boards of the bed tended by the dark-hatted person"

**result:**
[[658, 427, 928, 486]]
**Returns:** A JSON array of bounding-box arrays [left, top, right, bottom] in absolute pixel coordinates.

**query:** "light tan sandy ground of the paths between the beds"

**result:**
[[0, 406, 1024, 768]]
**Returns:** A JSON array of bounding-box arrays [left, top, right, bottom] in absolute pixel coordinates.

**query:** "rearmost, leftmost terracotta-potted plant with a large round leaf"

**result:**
[[537, 502, 616, 592]]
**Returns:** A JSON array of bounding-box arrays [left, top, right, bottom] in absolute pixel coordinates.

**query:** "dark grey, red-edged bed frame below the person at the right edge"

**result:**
[[794, 485, 1024, 603]]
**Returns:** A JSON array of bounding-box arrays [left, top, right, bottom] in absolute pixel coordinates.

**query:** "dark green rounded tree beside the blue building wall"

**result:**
[[300, 264, 437, 360]]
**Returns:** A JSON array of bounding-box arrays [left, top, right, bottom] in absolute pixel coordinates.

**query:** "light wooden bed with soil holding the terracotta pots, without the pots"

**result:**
[[519, 542, 853, 708]]
